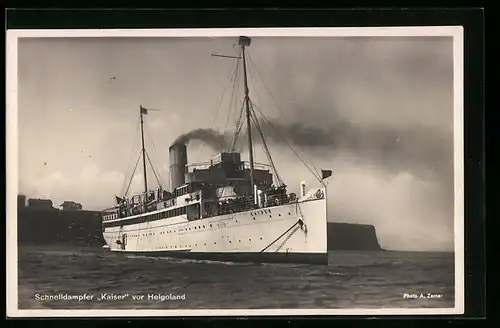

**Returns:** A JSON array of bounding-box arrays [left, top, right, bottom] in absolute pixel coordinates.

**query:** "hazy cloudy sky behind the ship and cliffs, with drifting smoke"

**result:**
[[18, 37, 454, 250]]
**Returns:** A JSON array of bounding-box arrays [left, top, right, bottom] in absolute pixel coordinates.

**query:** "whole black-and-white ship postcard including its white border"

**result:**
[[6, 26, 464, 317]]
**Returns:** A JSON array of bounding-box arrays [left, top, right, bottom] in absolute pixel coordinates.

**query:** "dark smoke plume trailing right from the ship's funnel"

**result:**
[[171, 116, 453, 187]]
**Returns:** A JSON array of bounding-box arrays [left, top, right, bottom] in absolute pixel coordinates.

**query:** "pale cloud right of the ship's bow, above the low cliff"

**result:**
[[328, 157, 454, 251]]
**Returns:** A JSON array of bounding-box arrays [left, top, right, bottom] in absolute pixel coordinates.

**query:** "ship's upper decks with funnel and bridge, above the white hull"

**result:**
[[103, 148, 286, 221]]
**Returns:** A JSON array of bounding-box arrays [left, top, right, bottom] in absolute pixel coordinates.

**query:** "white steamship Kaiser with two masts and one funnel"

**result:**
[[102, 36, 332, 265]]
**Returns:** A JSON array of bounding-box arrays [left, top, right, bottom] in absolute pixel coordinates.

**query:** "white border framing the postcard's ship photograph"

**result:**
[[6, 26, 465, 317]]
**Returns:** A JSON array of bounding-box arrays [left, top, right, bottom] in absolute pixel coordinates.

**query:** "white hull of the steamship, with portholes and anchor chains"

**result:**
[[103, 189, 327, 264]]
